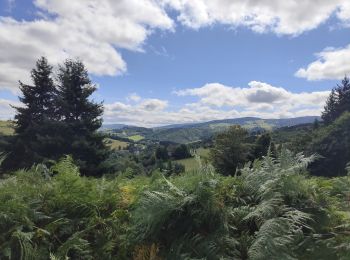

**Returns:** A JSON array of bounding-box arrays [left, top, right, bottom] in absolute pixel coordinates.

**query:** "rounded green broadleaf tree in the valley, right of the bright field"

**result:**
[[210, 125, 251, 175]]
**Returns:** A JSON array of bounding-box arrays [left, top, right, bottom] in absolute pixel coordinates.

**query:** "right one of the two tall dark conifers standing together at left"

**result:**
[[57, 60, 108, 175]]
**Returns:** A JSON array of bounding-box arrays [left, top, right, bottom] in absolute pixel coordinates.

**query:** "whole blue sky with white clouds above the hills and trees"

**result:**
[[0, 0, 350, 127]]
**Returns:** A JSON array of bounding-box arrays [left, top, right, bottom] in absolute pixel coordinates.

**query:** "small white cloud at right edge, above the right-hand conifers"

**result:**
[[295, 44, 350, 80]]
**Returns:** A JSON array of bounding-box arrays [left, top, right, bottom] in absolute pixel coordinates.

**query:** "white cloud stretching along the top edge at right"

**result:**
[[163, 0, 350, 35]]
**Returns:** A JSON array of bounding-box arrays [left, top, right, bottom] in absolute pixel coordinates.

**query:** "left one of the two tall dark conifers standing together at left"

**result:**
[[5, 57, 56, 168]]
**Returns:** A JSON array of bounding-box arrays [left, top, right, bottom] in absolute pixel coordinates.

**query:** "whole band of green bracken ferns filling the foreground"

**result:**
[[0, 149, 350, 260]]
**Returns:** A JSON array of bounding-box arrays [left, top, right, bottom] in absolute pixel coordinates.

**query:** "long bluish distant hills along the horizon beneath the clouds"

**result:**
[[102, 116, 320, 143]]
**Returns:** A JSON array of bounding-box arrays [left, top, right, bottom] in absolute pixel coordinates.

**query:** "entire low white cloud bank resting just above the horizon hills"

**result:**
[[104, 81, 329, 127]]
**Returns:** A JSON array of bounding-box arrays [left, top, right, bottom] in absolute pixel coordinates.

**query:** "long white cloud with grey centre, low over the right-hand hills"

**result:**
[[175, 81, 329, 117]]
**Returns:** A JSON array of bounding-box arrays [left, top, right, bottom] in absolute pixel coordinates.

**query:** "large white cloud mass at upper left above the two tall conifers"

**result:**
[[0, 0, 173, 92]]
